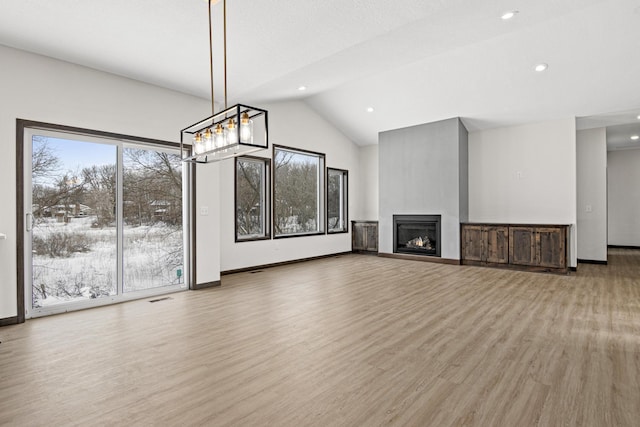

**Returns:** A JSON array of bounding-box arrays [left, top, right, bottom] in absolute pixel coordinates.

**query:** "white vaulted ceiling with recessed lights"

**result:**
[[0, 0, 640, 145]]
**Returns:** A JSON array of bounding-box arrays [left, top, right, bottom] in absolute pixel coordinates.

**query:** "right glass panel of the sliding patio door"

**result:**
[[122, 147, 184, 292]]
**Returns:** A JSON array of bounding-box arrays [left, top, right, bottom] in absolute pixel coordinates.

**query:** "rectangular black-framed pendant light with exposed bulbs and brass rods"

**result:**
[[180, 0, 269, 163]]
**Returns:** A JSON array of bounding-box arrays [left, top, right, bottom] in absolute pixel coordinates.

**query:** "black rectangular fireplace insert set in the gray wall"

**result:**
[[393, 215, 440, 257]]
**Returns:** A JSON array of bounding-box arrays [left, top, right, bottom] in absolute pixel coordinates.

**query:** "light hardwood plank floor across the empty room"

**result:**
[[0, 250, 640, 426]]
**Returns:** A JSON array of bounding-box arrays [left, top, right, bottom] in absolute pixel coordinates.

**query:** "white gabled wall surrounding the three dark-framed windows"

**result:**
[[220, 101, 361, 271]]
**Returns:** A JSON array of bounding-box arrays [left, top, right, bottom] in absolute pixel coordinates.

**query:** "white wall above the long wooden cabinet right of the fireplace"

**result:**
[[469, 118, 577, 267]]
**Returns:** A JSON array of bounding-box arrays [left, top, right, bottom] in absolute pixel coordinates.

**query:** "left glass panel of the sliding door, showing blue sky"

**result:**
[[30, 135, 118, 309]]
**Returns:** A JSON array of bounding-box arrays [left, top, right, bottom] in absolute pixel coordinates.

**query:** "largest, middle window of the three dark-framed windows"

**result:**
[[273, 146, 324, 237]]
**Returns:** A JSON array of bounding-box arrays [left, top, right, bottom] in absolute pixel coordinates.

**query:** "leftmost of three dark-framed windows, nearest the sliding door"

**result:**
[[236, 157, 271, 242]]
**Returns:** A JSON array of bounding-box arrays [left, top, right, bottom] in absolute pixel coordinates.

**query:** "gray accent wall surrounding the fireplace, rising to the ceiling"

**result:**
[[378, 118, 469, 259]]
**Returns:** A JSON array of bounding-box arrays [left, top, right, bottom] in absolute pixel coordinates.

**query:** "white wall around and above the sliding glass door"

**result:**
[[0, 46, 219, 319]]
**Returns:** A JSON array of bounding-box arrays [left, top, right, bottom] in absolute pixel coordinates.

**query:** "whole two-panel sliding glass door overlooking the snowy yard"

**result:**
[[24, 129, 188, 317]]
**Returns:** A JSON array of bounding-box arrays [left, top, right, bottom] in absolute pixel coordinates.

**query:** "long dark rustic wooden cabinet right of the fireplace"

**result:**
[[460, 223, 569, 273]]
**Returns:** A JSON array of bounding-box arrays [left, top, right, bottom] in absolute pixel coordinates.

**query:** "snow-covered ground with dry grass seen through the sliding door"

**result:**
[[33, 216, 184, 307]]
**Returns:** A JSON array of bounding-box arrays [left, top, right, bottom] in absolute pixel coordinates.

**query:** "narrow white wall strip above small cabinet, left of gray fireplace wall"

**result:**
[[358, 145, 379, 221]]
